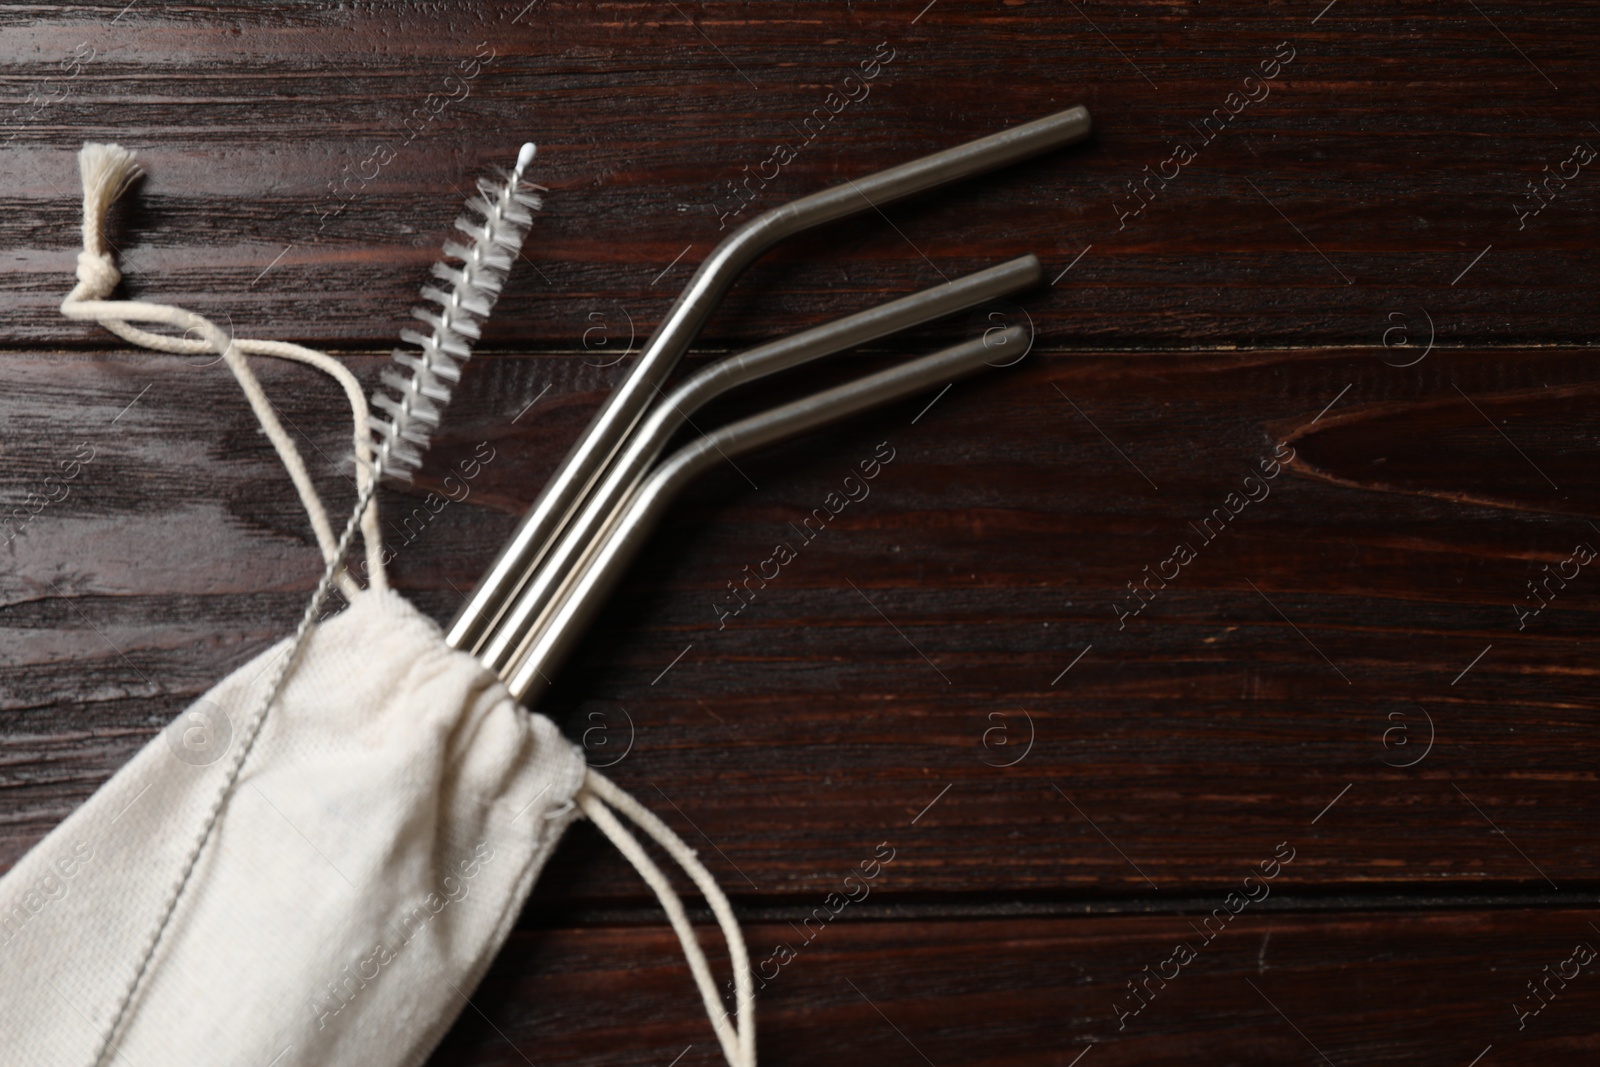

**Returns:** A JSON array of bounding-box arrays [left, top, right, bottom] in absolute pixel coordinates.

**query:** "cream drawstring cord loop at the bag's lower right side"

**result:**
[[574, 768, 755, 1067]]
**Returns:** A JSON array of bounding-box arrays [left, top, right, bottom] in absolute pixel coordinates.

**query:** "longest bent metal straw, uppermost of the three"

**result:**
[[457, 107, 1090, 653]]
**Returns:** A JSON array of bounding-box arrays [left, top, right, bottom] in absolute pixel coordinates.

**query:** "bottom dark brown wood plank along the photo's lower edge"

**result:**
[[430, 908, 1600, 1067]]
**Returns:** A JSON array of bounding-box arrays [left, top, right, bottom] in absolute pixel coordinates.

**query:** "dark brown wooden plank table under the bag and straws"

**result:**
[[0, 0, 1600, 1067]]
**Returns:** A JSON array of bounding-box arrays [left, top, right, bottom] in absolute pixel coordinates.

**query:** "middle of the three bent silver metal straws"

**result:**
[[478, 256, 1043, 670]]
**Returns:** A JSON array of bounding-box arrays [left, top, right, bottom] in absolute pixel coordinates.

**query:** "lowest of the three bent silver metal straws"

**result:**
[[499, 326, 1027, 704]]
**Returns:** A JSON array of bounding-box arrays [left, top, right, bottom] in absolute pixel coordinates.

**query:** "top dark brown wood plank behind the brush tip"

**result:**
[[0, 0, 1600, 349]]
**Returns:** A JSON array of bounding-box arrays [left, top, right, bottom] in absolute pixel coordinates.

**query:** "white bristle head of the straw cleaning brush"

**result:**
[[371, 144, 541, 482]]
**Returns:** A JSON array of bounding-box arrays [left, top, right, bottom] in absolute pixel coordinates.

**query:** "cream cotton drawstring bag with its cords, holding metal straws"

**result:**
[[0, 146, 755, 1067]]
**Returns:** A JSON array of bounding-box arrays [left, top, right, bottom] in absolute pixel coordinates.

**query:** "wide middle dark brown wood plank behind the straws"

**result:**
[[0, 349, 1600, 902]]
